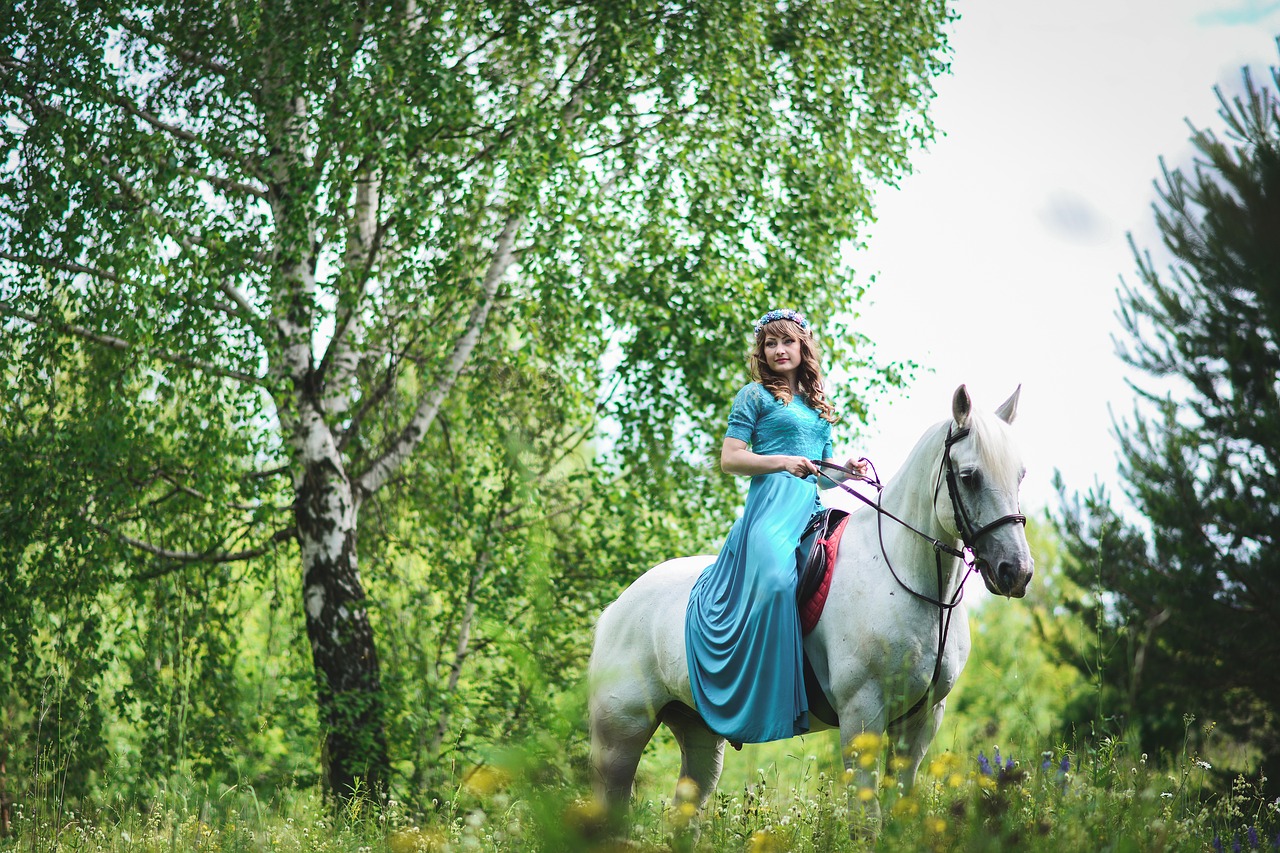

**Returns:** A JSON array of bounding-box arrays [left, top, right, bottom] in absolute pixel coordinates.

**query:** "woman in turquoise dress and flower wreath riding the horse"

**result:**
[[685, 309, 865, 744]]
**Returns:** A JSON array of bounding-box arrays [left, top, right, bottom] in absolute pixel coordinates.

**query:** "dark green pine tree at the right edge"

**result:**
[[1059, 48, 1280, 770]]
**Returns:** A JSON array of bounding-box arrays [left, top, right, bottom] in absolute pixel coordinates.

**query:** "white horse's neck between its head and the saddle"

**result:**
[[877, 427, 960, 597]]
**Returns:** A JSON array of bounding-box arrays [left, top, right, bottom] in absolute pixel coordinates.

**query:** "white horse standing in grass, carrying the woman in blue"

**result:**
[[588, 386, 1033, 818]]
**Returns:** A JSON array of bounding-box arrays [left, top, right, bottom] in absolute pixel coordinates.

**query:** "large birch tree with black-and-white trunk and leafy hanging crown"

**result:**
[[0, 0, 948, 797]]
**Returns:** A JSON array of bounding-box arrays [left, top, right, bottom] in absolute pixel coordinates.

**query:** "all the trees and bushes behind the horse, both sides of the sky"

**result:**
[[0, 3, 1280, 850]]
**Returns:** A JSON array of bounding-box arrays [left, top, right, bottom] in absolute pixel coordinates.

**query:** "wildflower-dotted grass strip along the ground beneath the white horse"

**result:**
[[0, 734, 1280, 853]]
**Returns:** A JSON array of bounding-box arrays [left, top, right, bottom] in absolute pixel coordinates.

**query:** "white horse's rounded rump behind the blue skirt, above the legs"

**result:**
[[589, 556, 716, 701]]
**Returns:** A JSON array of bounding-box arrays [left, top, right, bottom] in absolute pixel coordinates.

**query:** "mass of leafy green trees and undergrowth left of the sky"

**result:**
[[0, 0, 950, 793]]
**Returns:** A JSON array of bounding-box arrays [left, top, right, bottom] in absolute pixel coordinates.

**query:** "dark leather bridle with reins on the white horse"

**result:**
[[812, 417, 1027, 729]]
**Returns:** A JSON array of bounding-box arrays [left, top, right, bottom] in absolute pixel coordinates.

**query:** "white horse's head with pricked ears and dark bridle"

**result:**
[[934, 386, 1036, 598]]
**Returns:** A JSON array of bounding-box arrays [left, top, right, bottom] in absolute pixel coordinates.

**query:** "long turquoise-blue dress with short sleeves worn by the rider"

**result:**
[[685, 383, 831, 743]]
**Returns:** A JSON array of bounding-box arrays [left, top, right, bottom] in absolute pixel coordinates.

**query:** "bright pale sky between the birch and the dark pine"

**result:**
[[833, 0, 1280, 515]]
